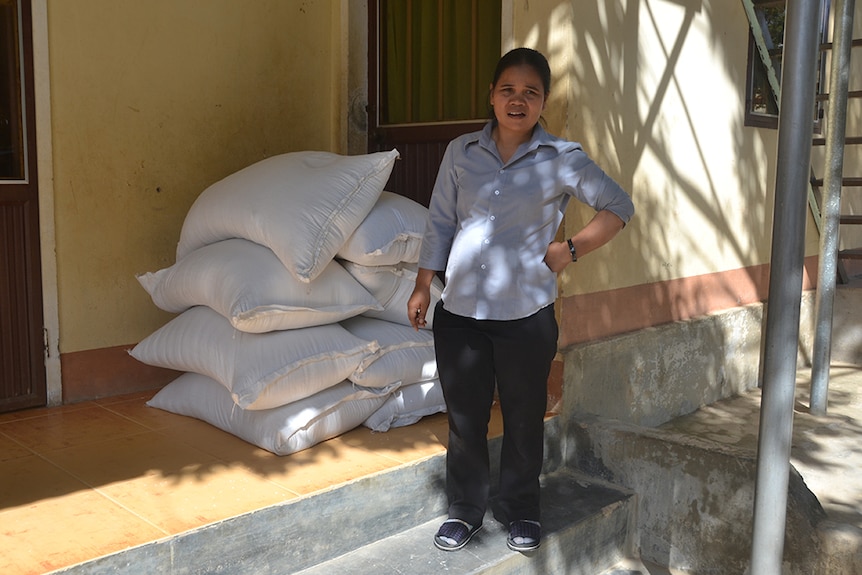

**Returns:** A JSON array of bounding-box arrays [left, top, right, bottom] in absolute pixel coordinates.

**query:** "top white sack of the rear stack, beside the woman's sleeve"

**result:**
[[336, 191, 428, 266]]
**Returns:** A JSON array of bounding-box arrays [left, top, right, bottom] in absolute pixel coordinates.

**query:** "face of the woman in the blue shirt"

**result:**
[[491, 65, 547, 136]]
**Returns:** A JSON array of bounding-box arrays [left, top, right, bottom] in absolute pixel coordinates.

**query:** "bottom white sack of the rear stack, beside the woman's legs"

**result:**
[[362, 379, 446, 431]]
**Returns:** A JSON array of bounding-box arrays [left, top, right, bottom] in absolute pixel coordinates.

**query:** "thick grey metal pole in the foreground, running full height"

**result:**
[[750, 0, 820, 575]]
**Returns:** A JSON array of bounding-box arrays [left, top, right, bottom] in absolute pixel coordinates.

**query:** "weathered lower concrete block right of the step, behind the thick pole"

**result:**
[[569, 418, 832, 575]]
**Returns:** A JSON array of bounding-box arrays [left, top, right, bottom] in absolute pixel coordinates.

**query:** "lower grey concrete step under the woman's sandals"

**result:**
[[297, 469, 636, 575]]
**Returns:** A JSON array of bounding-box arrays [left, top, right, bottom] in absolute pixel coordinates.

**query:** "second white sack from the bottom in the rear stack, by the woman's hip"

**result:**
[[341, 316, 437, 388]]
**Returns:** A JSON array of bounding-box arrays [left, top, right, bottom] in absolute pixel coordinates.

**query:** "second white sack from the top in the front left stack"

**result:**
[[137, 238, 383, 333]]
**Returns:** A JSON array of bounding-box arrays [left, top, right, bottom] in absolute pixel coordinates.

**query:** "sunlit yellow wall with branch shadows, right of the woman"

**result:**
[[513, 0, 818, 295]]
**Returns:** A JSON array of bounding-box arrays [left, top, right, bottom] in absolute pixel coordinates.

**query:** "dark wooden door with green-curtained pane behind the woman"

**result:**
[[368, 0, 502, 206]]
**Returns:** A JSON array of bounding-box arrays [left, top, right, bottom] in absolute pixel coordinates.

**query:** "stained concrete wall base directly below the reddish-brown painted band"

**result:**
[[560, 292, 814, 427]]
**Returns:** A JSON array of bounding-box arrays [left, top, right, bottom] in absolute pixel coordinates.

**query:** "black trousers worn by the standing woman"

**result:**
[[433, 302, 558, 525]]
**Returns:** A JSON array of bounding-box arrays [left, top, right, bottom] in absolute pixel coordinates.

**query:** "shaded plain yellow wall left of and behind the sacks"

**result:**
[[47, 0, 346, 353]]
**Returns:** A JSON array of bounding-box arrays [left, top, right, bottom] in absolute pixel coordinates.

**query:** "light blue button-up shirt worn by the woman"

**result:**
[[419, 121, 634, 320]]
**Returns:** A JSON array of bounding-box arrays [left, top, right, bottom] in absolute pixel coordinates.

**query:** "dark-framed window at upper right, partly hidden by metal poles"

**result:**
[[745, 0, 830, 132]]
